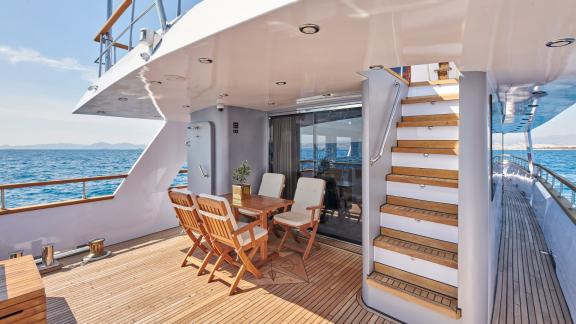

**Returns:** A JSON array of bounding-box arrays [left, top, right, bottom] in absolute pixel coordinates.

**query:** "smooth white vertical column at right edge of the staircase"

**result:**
[[458, 72, 492, 324]]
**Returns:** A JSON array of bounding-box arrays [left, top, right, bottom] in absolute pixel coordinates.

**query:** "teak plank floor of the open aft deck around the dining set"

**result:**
[[44, 229, 390, 323]]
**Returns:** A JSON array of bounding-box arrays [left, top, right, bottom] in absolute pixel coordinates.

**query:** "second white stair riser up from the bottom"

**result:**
[[380, 213, 458, 243]]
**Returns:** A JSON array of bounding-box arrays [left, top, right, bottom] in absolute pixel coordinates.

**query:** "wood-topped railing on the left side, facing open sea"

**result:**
[[0, 169, 188, 215]]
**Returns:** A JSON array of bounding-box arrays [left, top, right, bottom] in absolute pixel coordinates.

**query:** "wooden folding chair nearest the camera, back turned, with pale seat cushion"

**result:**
[[197, 195, 268, 295]]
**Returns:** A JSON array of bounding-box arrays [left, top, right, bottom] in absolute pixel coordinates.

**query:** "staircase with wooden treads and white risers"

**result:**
[[367, 79, 461, 319]]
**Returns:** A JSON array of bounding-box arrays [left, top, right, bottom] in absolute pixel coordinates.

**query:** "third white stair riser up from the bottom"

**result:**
[[386, 181, 458, 204]]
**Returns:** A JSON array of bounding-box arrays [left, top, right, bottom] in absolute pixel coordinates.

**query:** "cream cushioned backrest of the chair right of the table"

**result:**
[[291, 178, 326, 220]]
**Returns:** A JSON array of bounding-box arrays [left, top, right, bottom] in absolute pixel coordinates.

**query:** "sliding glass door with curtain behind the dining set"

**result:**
[[270, 108, 362, 244]]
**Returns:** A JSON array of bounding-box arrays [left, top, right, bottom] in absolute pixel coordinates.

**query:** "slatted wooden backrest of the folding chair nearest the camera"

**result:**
[[196, 194, 238, 246]]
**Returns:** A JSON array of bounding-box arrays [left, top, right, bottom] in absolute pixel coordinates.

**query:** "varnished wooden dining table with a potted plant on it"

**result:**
[[222, 194, 294, 267]]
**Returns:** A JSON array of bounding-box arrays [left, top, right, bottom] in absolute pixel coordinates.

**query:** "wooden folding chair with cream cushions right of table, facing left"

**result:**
[[274, 178, 326, 260]]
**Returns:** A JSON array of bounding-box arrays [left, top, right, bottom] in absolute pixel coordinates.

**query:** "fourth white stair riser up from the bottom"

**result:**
[[392, 152, 458, 170]]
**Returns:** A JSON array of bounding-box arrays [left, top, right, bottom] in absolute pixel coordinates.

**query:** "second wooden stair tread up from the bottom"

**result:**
[[374, 235, 458, 269]]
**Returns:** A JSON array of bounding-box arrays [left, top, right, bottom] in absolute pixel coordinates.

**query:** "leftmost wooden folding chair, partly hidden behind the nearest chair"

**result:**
[[168, 189, 234, 276]]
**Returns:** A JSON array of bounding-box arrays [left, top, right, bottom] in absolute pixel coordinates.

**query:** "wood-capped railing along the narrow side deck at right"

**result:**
[[504, 155, 576, 212]]
